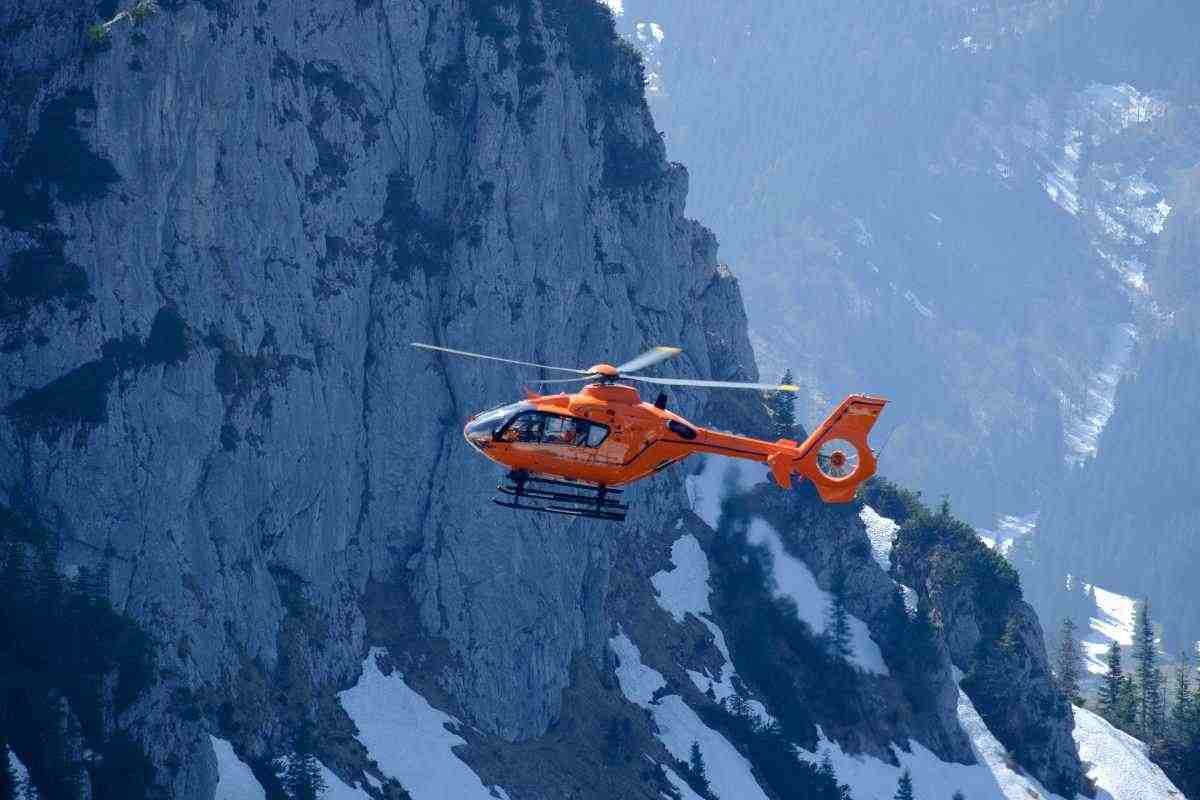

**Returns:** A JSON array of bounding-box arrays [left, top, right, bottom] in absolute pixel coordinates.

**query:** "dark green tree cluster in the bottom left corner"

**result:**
[[0, 505, 156, 800]]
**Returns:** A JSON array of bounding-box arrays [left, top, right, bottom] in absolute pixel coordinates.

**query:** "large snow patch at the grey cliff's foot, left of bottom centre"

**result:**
[[337, 648, 506, 800]]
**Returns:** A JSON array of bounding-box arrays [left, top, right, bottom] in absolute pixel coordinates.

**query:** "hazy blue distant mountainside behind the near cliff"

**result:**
[[623, 0, 1200, 649]]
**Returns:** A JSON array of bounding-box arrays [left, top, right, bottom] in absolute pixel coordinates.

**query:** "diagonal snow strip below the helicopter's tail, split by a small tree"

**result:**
[[746, 519, 889, 675]]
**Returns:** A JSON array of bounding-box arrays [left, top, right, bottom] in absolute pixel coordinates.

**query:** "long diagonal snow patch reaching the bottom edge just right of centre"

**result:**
[[609, 632, 767, 800]]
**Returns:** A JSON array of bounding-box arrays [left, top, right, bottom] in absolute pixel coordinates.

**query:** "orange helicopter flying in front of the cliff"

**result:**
[[413, 342, 887, 522]]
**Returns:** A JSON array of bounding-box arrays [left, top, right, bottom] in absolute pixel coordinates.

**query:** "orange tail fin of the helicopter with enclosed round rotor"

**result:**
[[768, 395, 887, 503]]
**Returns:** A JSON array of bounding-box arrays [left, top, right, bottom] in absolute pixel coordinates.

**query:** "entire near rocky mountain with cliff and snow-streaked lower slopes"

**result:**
[[0, 0, 1180, 800]]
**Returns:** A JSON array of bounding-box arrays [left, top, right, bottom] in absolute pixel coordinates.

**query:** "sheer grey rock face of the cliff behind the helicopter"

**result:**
[[0, 0, 754, 798]]
